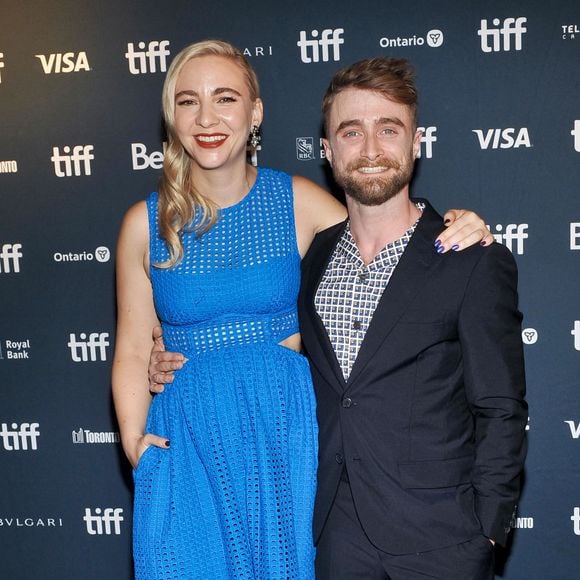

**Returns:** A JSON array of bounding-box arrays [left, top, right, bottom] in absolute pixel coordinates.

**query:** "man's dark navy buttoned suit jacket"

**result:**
[[299, 200, 527, 554]]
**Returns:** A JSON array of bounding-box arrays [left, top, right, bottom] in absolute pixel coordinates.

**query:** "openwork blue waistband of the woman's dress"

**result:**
[[163, 308, 298, 354]]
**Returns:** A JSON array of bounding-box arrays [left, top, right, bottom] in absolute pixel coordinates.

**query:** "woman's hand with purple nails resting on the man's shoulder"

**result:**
[[435, 209, 494, 254]]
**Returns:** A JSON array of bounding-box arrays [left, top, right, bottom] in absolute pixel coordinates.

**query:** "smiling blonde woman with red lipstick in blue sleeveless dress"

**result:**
[[113, 40, 494, 580]]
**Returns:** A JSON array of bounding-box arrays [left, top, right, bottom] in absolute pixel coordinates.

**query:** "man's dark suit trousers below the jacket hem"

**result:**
[[316, 480, 494, 580]]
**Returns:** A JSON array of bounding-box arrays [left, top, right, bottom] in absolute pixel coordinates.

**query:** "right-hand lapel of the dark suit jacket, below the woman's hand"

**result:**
[[348, 200, 443, 388]]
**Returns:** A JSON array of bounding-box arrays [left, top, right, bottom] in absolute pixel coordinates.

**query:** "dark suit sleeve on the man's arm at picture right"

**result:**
[[459, 244, 528, 545]]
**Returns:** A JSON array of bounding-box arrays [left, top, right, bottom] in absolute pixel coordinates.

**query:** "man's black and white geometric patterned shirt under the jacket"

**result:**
[[314, 203, 425, 380]]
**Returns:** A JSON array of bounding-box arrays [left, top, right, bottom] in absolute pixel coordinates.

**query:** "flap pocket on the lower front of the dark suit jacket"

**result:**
[[398, 455, 473, 489]]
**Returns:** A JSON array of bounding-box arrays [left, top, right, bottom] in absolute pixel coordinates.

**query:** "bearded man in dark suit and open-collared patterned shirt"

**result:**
[[299, 58, 527, 580]]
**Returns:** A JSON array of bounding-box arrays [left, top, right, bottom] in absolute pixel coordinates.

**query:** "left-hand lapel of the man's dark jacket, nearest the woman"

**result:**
[[300, 221, 346, 393]]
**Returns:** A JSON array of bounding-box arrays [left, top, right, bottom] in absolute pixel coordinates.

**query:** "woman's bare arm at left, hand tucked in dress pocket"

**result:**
[[113, 202, 168, 467]]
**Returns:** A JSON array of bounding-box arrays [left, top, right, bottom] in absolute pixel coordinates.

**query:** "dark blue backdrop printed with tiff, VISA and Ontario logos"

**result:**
[[0, 0, 580, 580]]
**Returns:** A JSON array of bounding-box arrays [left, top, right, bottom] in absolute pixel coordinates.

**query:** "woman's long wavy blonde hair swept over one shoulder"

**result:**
[[155, 40, 260, 268]]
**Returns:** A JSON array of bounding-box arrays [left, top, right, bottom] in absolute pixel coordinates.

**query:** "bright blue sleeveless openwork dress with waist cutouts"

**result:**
[[133, 169, 317, 580]]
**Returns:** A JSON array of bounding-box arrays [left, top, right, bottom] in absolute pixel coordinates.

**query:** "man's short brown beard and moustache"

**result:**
[[334, 156, 414, 205]]
